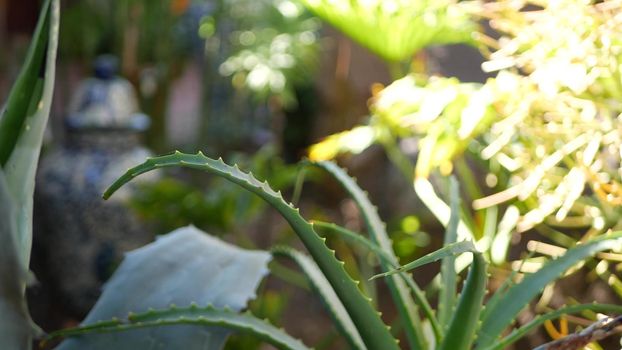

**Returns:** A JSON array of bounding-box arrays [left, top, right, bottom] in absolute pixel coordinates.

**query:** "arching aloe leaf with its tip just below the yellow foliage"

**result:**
[[310, 161, 434, 349]]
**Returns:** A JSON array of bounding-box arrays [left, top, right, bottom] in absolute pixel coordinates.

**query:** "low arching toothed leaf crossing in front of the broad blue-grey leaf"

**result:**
[[47, 305, 309, 350]]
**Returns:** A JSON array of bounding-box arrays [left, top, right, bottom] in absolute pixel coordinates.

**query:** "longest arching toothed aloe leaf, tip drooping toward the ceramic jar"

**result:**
[[104, 152, 398, 350]]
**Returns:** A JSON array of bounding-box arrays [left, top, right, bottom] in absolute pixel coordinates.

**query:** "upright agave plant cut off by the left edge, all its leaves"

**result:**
[[0, 1, 59, 349]]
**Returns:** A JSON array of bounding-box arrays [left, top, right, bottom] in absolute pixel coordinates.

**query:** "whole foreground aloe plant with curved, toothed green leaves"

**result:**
[[49, 152, 622, 349]]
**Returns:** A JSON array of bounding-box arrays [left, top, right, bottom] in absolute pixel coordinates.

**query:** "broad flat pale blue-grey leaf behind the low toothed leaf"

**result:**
[[59, 226, 271, 350]]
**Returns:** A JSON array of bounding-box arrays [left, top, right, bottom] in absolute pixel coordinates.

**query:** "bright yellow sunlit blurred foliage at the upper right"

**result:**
[[310, 1, 622, 274]]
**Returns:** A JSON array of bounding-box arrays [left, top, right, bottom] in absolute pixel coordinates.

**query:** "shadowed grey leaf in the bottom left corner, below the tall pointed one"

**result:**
[[0, 168, 33, 349]]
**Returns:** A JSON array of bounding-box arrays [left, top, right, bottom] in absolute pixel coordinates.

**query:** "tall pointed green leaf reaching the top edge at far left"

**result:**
[[0, 0, 60, 266]]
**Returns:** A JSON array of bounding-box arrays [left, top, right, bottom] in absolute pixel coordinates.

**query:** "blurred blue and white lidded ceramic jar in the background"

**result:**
[[35, 57, 157, 318]]
